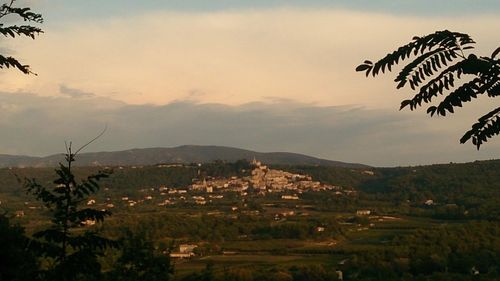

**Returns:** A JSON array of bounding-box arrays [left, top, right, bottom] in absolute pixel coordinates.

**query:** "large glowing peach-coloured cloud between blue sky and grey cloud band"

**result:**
[[0, 7, 500, 107]]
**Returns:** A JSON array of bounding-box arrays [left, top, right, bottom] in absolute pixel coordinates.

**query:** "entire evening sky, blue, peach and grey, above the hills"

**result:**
[[0, 0, 500, 166]]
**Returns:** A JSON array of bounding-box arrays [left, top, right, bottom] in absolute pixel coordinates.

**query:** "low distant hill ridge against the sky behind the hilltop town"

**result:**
[[0, 145, 368, 168]]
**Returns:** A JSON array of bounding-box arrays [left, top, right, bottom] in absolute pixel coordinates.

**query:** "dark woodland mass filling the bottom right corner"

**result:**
[[343, 221, 500, 281]]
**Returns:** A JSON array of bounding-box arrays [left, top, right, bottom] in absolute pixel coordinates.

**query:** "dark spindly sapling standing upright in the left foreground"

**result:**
[[25, 145, 117, 280]]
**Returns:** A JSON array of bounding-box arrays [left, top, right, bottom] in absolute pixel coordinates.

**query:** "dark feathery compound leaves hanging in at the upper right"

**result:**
[[356, 30, 500, 149]]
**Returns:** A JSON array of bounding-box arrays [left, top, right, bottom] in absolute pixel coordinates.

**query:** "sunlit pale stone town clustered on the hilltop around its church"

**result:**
[[112, 159, 356, 207]]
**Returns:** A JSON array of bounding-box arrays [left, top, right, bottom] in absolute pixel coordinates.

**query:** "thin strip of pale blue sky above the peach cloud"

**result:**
[[37, 0, 500, 21]]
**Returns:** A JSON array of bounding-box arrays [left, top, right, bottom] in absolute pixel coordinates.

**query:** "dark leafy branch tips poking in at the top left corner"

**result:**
[[0, 0, 43, 74]]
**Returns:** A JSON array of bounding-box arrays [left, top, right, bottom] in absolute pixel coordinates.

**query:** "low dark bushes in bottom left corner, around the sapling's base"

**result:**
[[0, 212, 173, 281]]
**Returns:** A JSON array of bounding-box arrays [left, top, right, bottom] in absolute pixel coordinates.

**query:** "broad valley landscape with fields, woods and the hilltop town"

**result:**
[[0, 160, 500, 280]]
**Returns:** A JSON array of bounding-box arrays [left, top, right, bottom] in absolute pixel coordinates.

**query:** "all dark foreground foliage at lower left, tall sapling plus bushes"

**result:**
[[0, 154, 176, 281]]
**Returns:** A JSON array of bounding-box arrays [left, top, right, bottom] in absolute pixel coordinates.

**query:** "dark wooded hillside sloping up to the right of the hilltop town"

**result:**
[[283, 160, 500, 219]]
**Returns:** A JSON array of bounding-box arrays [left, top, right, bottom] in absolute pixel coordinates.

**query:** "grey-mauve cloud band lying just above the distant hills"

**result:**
[[0, 93, 500, 166]]
